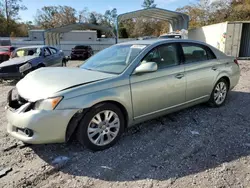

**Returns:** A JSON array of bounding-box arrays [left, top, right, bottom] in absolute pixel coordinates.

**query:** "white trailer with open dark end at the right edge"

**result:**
[[188, 21, 250, 59]]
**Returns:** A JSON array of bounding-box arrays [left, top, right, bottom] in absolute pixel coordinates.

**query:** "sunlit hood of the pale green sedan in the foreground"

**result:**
[[16, 67, 115, 102]]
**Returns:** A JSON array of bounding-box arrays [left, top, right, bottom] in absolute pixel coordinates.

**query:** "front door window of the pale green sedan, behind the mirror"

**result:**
[[141, 44, 179, 69]]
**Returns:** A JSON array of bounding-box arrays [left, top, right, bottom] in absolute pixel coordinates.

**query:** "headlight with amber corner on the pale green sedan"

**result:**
[[34, 97, 63, 110]]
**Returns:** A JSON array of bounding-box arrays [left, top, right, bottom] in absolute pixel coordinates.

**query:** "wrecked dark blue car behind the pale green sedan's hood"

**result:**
[[0, 46, 64, 79]]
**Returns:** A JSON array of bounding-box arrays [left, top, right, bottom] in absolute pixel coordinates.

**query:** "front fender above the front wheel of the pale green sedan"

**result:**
[[57, 79, 133, 125]]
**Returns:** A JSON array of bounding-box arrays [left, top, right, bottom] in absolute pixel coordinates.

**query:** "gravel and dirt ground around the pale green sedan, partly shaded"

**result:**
[[0, 61, 250, 188]]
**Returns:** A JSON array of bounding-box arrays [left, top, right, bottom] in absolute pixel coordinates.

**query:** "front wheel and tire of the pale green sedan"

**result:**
[[76, 103, 125, 151]]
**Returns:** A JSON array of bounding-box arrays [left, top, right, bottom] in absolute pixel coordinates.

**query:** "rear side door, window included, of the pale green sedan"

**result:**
[[181, 43, 218, 102]]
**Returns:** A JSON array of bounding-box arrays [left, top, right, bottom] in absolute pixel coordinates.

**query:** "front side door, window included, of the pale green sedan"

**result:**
[[130, 43, 186, 119]]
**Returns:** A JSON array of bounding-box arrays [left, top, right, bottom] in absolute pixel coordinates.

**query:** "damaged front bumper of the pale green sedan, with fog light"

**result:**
[[6, 89, 78, 144]]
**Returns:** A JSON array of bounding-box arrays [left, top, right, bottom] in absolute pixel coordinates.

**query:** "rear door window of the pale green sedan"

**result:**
[[181, 44, 216, 63]]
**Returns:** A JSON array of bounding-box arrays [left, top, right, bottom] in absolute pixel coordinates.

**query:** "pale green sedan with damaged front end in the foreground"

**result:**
[[7, 39, 240, 150]]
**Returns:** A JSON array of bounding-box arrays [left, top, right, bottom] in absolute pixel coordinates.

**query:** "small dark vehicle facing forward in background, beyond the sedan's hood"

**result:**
[[71, 45, 94, 59]]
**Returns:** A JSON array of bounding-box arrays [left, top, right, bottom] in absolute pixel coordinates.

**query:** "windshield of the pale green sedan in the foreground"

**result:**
[[81, 44, 146, 74]]
